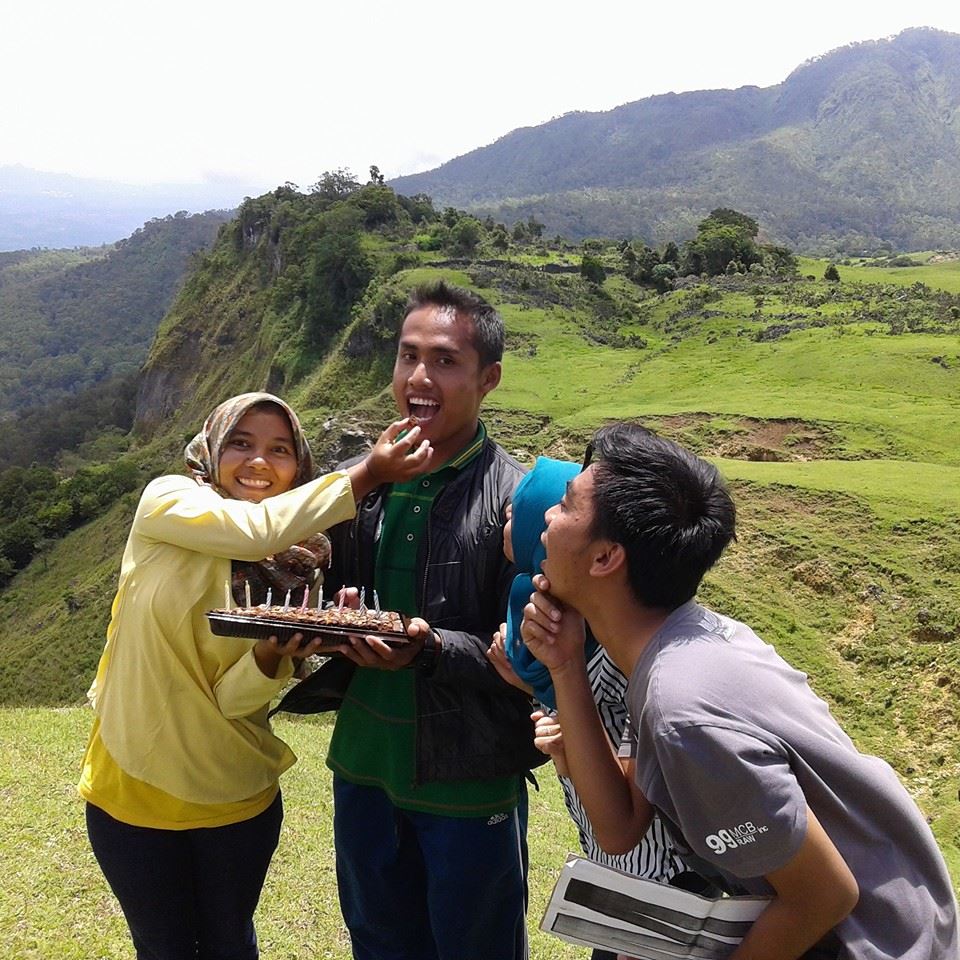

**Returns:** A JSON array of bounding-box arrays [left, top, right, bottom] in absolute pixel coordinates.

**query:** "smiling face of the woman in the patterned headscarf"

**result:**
[[220, 407, 297, 503]]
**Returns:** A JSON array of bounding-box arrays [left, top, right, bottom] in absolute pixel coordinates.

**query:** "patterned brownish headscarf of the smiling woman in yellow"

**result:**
[[183, 393, 330, 604]]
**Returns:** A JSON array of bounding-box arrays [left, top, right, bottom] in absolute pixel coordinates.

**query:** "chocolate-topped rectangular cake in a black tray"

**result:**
[[207, 605, 408, 646]]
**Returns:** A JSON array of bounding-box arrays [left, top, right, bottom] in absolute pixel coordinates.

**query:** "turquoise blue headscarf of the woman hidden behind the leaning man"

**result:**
[[504, 457, 592, 710]]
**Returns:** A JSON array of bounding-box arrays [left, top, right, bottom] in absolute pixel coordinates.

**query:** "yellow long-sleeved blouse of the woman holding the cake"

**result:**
[[80, 472, 355, 825]]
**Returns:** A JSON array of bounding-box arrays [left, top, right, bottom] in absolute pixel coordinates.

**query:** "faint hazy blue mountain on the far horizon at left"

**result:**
[[0, 166, 262, 251]]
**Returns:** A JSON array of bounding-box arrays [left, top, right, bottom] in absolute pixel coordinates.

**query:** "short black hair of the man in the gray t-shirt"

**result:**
[[588, 423, 737, 610]]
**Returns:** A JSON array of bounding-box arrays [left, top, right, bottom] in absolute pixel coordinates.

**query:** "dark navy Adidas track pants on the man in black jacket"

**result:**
[[333, 776, 527, 960]]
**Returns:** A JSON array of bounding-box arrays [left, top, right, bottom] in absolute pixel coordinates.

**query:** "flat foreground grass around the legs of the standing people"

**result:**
[[0, 708, 585, 960]]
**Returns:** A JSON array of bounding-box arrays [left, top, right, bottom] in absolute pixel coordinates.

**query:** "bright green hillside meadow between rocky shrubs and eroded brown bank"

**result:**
[[490, 282, 960, 464]]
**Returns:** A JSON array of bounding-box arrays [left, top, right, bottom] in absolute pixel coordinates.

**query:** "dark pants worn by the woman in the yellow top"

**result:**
[[87, 793, 283, 960]]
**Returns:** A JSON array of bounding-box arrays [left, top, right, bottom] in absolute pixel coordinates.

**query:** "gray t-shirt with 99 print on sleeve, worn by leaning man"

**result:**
[[620, 601, 960, 960]]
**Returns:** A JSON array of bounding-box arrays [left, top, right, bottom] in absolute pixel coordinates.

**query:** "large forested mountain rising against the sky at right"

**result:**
[[391, 28, 960, 252]]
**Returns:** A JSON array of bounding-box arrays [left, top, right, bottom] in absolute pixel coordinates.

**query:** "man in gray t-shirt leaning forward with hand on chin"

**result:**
[[521, 424, 960, 960]]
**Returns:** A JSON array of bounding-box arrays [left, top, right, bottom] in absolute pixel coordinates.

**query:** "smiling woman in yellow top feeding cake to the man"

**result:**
[[79, 393, 432, 960]]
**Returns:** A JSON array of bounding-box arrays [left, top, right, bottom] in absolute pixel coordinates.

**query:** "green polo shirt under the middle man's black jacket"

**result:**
[[327, 424, 519, 817]]
